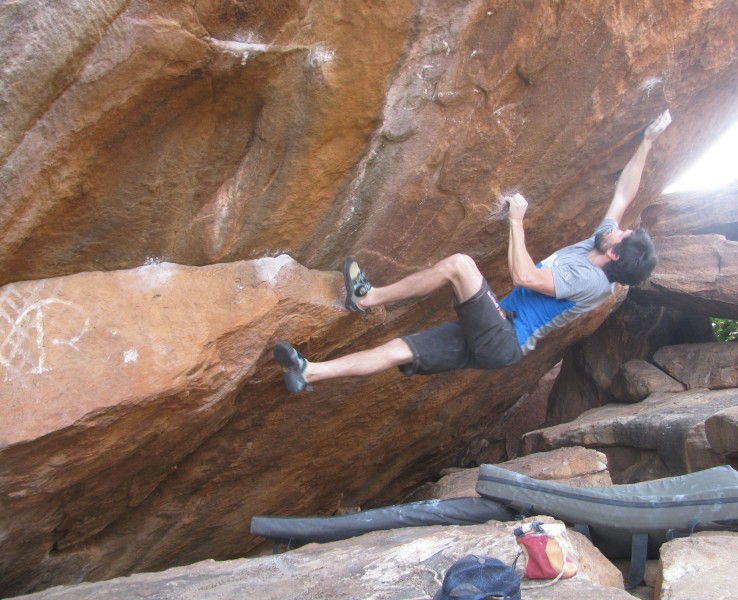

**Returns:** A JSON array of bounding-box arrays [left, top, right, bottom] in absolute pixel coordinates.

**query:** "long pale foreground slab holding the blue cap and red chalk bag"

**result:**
[[14, 517, 632, 600]]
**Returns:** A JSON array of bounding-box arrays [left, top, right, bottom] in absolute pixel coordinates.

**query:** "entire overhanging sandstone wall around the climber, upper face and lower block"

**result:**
[[0, 0, 738, 597]]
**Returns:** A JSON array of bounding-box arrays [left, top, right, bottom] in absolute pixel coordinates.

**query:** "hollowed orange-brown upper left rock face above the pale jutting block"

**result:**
[[0, 0, 415, 283]]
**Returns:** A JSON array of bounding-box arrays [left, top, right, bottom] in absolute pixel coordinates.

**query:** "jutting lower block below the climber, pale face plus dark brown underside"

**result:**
[[0, 255, 616, 593]]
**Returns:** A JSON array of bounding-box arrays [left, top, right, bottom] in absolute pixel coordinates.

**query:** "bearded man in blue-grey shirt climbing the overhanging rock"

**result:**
[[274, 110, 671, 392]]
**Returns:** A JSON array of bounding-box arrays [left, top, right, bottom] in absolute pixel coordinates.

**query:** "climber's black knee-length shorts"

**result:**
[[399, 280, 523, 377]]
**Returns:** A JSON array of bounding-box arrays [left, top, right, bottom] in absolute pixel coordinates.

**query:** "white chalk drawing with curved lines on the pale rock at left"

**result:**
[[0, 286, 90, 381]]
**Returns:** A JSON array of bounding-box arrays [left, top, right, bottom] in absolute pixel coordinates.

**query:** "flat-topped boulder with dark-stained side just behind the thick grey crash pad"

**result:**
[[522, 389, 738, 483]]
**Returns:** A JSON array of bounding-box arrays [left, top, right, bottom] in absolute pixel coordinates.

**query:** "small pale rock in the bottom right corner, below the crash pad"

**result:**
[[656, 532, 738, 600]]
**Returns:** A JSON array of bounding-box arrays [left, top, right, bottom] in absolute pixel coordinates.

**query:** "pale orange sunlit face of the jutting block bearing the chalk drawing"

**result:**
[[0, 255, 345, 448]]
